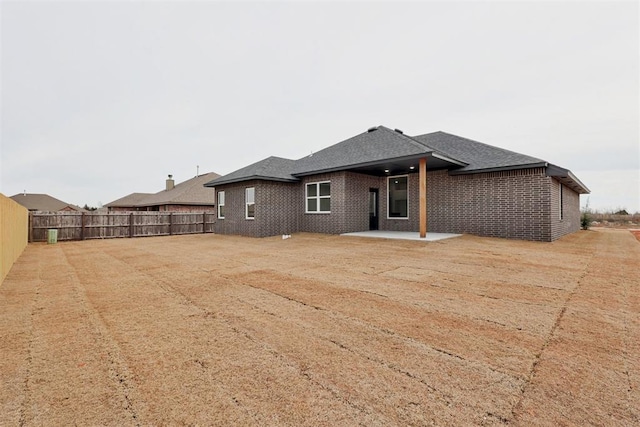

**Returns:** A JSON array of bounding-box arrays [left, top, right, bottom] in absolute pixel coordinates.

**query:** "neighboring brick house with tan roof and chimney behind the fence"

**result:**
[[105, 172, 220, 212]]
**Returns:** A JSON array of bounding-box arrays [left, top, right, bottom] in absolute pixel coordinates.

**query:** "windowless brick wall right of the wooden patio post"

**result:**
[[427, 168, 552, 241]]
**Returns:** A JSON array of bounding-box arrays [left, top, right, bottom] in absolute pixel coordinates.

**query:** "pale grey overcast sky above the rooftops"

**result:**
[[0, 1, 640, 211]]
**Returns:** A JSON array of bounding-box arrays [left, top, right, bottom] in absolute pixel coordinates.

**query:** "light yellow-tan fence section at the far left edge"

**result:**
[[0, 194, 29, 283]]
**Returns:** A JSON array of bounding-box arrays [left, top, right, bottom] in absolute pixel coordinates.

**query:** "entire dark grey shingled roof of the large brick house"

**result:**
[[206, 126, 589, 193]]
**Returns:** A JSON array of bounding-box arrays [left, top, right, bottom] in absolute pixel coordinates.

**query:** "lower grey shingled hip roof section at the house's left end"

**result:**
[[205, 156, 298, 187]]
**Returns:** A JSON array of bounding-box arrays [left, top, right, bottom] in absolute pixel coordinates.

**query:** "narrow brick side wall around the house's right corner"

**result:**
[[548, 178, 580, 240]]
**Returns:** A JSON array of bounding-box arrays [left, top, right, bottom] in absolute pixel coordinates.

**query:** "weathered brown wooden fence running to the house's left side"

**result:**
[[29, 212, 215, 242]]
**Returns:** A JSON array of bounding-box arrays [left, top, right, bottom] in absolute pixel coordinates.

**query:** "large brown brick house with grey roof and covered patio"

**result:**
[[205, 126, 589, 241]]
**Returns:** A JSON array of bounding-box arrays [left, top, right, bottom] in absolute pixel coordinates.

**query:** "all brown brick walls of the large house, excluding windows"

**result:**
[[215, 168, 580, 241]]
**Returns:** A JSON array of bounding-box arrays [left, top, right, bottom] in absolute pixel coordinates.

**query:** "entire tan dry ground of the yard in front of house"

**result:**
[[0, 229, 640, 426]]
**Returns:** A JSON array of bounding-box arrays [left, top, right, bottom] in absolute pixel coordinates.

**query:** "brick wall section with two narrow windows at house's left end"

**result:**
[[214, 181, 303, 237]]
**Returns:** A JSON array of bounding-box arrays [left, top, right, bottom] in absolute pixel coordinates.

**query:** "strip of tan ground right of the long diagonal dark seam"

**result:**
[[511, 232, 640, 425]]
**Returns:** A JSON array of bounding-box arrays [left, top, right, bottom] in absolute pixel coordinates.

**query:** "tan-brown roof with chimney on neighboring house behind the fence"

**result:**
[[105, 172, 220, 207]]
